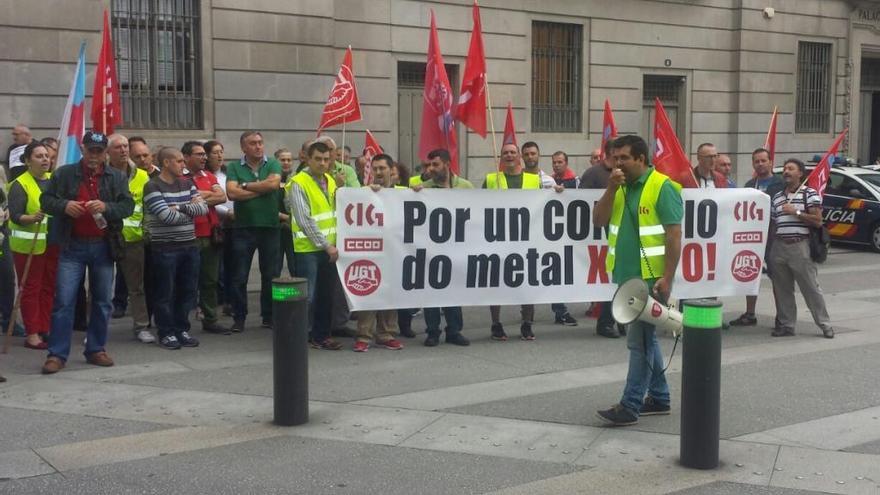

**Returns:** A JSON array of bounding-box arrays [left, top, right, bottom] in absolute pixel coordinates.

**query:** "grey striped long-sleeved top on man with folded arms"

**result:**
[[144, 177, 208, 247]]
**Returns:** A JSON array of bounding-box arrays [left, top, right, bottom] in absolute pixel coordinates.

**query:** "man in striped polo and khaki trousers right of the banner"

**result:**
[[770, 158, 834, 339]]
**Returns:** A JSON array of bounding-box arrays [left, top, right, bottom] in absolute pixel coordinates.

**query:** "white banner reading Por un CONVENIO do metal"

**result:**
[[336, 187, 770, 311]]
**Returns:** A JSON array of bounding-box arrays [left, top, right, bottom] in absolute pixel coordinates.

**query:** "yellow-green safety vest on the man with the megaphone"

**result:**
[[605, 170, 681, 280]]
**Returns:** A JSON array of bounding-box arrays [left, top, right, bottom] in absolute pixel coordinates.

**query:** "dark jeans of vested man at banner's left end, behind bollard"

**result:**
[[294, 251, 339, 342]]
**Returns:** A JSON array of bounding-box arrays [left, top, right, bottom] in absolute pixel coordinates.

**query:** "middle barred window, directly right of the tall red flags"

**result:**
[[532, 21, 583, 132]]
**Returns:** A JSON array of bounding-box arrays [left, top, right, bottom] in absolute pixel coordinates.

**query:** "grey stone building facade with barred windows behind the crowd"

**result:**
[[0, 0, 880, 181]]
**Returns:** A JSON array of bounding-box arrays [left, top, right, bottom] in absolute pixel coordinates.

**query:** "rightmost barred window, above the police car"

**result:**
[[794, 41, 831, 132]]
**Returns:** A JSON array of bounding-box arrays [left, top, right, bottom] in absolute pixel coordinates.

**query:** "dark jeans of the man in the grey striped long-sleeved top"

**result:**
[[153, 245, 200, 338]]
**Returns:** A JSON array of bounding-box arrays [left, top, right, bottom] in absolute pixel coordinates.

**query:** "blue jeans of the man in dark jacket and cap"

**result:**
[[49, 239, 113, 361]]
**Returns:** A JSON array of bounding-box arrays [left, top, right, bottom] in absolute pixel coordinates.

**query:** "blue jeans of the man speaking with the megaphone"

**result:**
[[624, 318, 669, 416]]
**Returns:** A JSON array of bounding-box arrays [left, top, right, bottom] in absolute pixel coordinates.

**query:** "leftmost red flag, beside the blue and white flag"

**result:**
[[92, 10, 122, 134]]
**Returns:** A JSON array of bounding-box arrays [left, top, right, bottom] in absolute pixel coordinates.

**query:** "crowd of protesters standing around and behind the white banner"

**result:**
[[0, 125, 833, 374]]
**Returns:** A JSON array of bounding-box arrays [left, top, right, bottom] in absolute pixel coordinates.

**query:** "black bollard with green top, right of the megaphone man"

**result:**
[[680, 299, 723, 469]]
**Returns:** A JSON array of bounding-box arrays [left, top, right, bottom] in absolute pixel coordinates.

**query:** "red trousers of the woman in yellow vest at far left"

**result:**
[[13, 246, 58, 335]]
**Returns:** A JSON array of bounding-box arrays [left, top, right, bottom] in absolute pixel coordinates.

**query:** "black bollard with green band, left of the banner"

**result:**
[[272, 278, 309, 426]]
